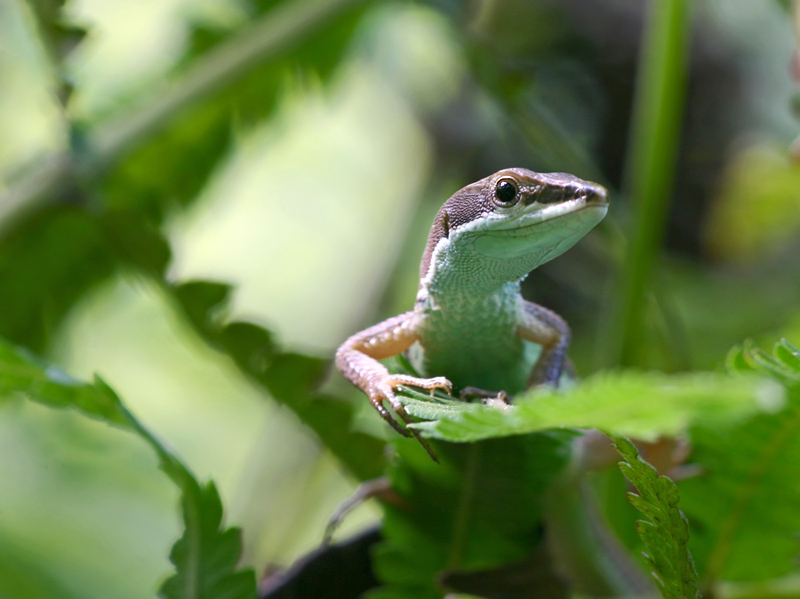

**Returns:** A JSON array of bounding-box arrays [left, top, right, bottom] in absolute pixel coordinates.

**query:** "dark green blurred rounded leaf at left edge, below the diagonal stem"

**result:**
[[0, 206, 170, 352]]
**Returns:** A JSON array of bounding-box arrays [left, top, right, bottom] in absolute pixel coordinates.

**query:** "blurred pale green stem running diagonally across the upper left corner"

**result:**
[[0, 0, 365, 234]]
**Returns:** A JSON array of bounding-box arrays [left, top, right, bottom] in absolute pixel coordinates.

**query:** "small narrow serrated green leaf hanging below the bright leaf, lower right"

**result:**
[[613, 436, 699, 599]]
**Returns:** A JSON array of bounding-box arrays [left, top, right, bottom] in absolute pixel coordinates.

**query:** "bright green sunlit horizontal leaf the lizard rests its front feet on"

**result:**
[[402, 371, 782, 442]]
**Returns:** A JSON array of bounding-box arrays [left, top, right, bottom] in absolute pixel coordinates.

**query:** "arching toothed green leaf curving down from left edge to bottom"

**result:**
[[0, 341, 256, 599]]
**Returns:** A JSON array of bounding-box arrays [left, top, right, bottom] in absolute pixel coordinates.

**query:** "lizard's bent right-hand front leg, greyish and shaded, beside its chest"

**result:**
[[517, 301, 570, 387]]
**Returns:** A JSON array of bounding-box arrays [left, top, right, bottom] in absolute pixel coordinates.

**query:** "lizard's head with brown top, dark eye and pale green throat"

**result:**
[[421, 168, 608, 284]]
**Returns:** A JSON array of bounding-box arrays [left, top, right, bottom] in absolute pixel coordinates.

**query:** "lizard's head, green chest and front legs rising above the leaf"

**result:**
[[336, 168, 608, 452]]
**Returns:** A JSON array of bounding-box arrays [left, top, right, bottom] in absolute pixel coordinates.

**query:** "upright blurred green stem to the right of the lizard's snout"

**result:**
[[604, 0, 690, 365]]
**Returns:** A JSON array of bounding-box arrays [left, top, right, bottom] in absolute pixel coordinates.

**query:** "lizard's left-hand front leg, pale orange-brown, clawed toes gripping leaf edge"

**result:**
[[336, 312, 453, 459]]
